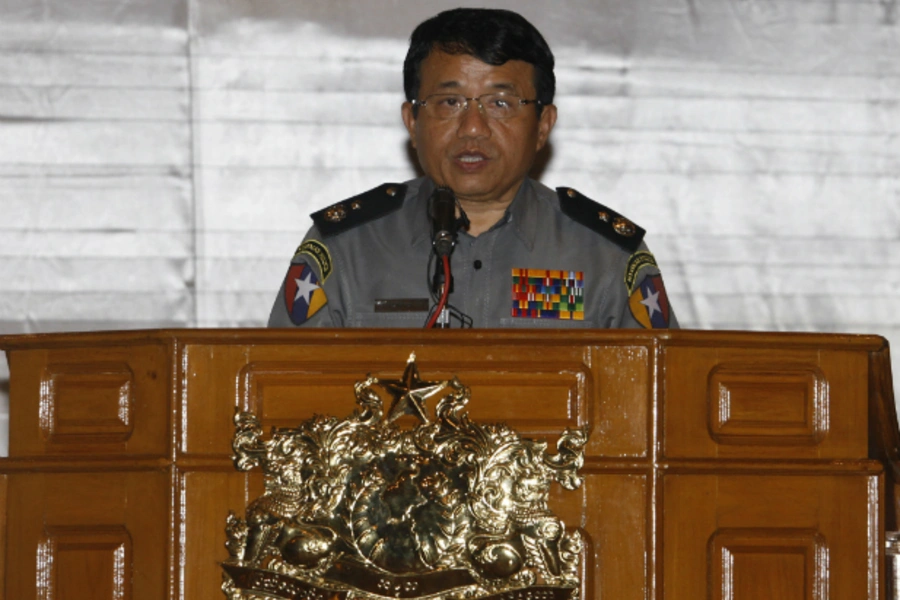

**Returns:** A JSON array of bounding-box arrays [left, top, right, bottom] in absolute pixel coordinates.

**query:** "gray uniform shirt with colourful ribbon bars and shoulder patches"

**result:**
[[269, 178, 677, 328]]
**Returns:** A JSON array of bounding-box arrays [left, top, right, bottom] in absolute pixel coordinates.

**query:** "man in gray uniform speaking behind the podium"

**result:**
[[269, 9, 677, 328]]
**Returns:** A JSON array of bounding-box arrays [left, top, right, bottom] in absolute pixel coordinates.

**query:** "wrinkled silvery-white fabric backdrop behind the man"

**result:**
[[0, 0, 900, 447]]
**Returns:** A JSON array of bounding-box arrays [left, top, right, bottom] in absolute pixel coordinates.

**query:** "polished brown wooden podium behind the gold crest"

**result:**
[[0, 330, 900, 600]]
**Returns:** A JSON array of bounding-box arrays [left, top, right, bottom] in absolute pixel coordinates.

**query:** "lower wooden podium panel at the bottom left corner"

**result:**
[[6, 472, 171, 600]]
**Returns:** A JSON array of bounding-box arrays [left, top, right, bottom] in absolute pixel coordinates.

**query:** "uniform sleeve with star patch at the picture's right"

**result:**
[[609, 244, 678, 329]]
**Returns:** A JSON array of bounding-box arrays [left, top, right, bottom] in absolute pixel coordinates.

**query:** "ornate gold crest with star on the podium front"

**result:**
[[222, 355, 587, 600]]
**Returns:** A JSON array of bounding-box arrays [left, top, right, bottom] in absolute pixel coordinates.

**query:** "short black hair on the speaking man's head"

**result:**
[[403, 8, 556, 109]]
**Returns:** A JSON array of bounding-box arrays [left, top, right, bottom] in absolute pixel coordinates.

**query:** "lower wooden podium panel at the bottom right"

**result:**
[[663, 473, 881, 600]]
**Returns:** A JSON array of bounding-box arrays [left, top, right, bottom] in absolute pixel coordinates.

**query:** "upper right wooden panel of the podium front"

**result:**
[[662, 346, 868, 459]]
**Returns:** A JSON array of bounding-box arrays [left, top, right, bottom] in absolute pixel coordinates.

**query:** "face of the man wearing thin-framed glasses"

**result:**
[[402, 50, 556, 205]]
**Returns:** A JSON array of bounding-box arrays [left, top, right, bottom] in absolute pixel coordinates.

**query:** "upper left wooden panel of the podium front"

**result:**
[[9, 344, 172, 457]]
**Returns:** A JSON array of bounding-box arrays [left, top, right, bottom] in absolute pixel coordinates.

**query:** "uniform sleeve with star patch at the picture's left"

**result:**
[[268, 228, 342, 327]]
